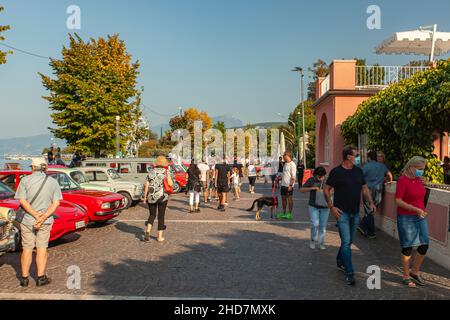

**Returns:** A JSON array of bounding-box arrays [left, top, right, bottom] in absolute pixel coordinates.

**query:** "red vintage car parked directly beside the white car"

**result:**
[[0, 170, 125, 224]]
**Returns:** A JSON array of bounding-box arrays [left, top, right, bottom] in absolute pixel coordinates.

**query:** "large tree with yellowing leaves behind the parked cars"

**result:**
[[40, 34, 142, 157]]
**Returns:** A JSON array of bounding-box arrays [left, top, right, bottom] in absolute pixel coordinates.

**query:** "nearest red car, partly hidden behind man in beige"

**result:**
[[0, 182, 86, 245]]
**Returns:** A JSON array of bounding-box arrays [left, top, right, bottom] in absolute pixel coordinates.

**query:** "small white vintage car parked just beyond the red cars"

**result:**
[[77, 167, 144, 208]]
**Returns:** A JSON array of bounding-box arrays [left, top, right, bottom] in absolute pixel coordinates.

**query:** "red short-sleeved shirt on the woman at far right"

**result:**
[[395, 176, 426, 215]]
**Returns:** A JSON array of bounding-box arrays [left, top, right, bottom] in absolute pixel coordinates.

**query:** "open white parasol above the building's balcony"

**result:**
[[375, 24, 450, 62]]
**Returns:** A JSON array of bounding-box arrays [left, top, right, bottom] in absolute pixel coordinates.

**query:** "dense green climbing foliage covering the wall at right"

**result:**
[[341, 60, 450, 183]]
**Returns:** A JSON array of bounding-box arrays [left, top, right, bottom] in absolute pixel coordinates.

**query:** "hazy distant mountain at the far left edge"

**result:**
[[0, 134, 66, 155]]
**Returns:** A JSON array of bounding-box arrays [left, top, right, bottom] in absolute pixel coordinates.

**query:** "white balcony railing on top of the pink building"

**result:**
[[356, 65, 430, 89]]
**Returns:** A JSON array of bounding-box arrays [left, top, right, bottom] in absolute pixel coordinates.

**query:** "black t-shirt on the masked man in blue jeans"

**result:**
[[326, 165, 366, 213]]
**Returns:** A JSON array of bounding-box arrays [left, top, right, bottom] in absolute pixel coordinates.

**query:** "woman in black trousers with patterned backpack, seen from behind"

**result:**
[[143, 156, 173, 242]]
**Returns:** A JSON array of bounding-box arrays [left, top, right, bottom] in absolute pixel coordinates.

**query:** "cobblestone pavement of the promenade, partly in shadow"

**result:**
[[0, 184, 450, 300]]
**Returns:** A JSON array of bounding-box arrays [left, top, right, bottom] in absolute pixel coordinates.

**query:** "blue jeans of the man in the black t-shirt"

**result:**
[[336, 212, 359, 275]]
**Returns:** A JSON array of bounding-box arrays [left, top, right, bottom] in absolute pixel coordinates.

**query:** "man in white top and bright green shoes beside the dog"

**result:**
[[278, 152, 297, 220]]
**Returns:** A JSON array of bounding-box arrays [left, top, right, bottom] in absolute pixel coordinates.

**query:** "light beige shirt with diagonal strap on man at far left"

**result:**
[[14, 172, 63, 226]]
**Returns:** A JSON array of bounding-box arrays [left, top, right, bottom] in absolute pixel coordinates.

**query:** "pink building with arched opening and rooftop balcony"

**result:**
[[313, 60, 450, 171]]
